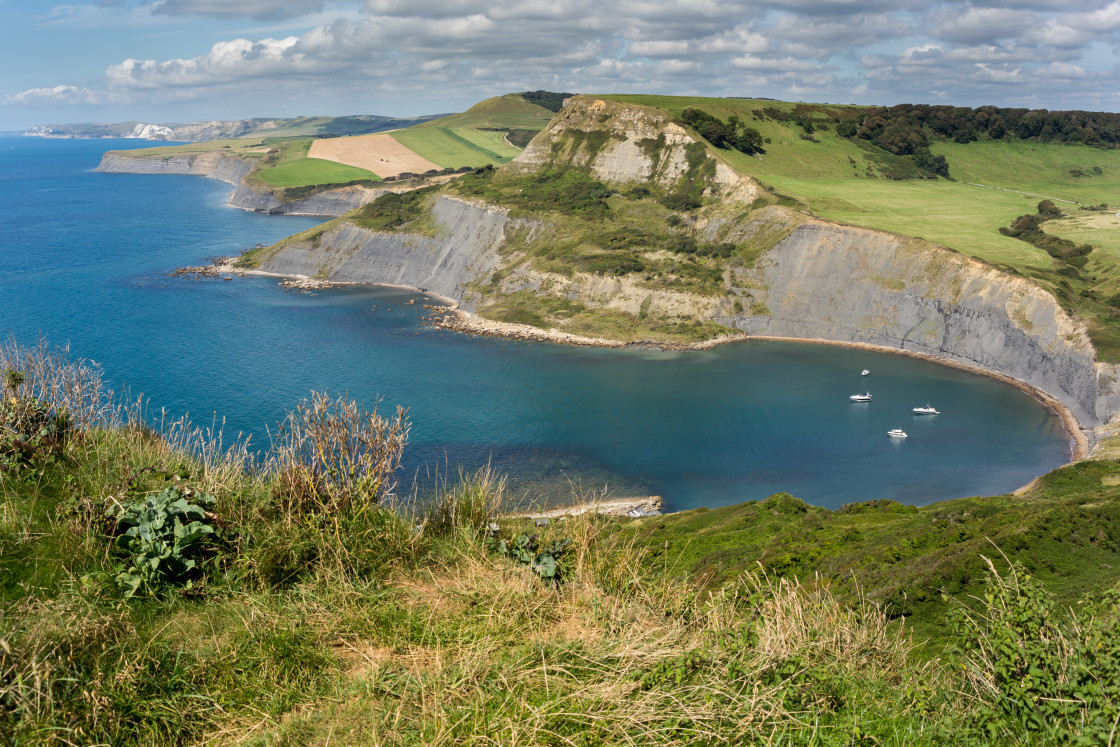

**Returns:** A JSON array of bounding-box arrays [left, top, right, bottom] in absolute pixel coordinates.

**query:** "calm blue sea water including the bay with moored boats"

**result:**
[[0, 138, 1068, 510]]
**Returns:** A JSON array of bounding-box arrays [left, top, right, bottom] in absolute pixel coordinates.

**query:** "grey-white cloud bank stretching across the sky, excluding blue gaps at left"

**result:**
[[3, 0, 1120, 119]]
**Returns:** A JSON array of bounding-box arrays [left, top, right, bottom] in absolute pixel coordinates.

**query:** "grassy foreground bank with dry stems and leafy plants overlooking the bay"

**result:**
[[0, 344, 1120, 745]]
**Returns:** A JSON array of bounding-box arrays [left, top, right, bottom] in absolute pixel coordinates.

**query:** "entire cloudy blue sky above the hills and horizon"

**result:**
[[0, 0, 1120, 130]]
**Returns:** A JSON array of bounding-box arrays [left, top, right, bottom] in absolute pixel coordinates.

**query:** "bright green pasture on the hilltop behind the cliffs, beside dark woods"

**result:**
[[610, 95, 1120, 267]]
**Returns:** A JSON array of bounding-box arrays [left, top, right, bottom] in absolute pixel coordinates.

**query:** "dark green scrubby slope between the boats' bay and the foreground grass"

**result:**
[[625, 461, 1120, 644]]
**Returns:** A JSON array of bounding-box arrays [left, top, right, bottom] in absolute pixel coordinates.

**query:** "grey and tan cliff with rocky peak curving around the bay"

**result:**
[[243, 97, 1120, 439]]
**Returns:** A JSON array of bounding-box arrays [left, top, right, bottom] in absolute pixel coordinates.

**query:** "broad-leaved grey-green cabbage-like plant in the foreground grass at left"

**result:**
[[105, 487, 218, 597]]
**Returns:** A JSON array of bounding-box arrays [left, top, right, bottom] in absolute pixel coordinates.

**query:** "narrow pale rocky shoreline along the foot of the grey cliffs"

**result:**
[[183, 264, 1090, 468]]
